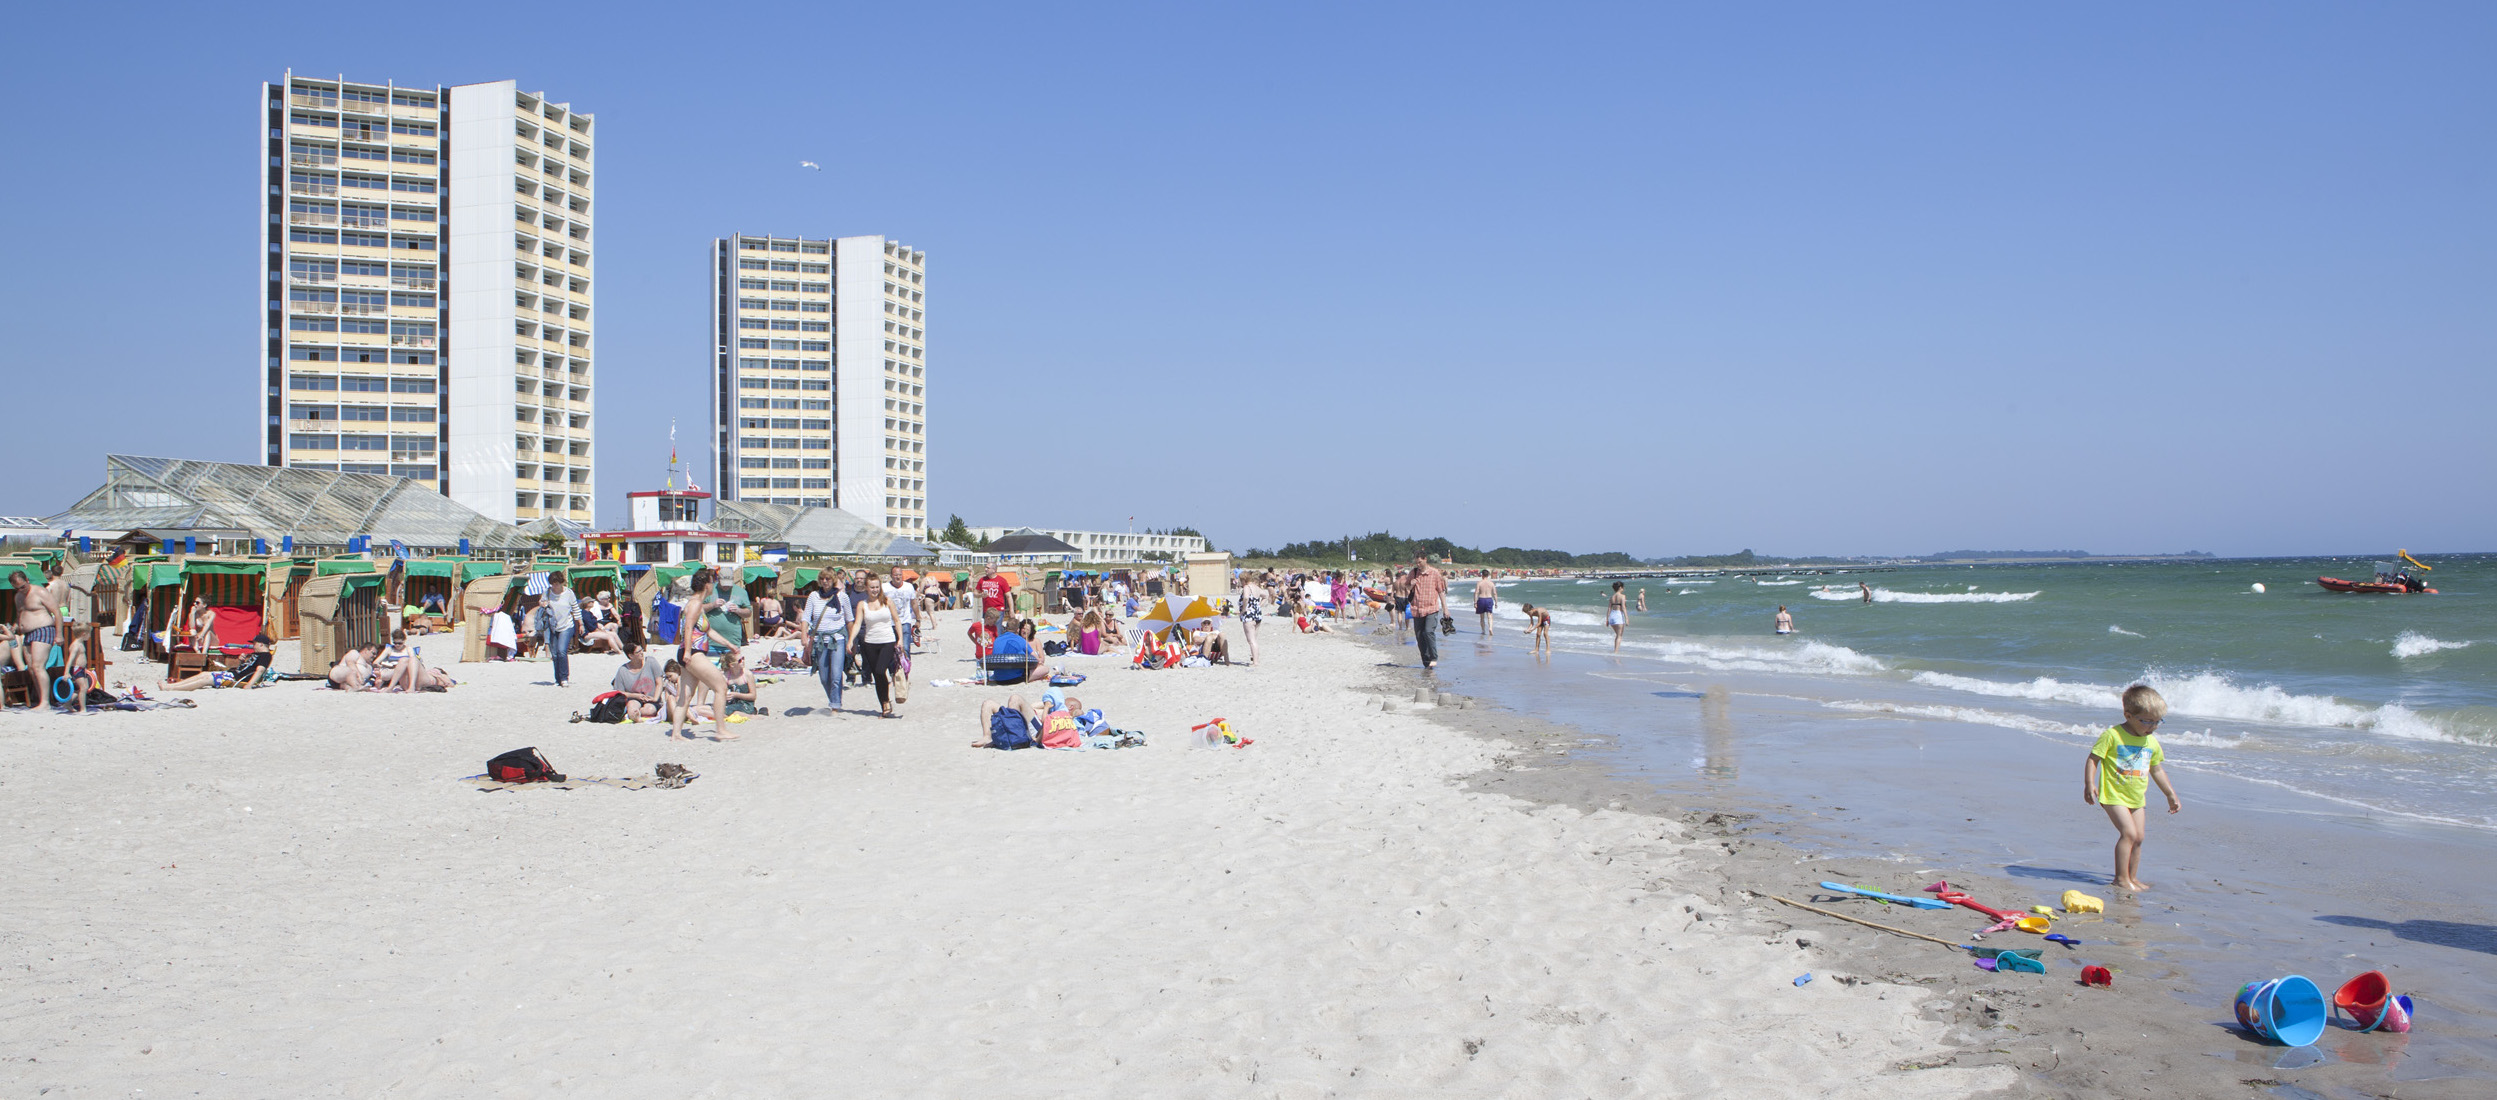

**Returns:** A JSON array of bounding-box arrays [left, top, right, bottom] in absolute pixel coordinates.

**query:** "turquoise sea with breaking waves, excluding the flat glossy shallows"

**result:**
[[1488, 554, 2497, 831]]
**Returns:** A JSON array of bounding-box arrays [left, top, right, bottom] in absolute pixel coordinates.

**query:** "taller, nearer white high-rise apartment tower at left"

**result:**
[[262, 72, 597, 524]]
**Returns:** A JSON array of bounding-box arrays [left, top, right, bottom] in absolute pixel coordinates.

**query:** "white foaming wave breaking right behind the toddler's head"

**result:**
[[1910, 671, 2487, 741]]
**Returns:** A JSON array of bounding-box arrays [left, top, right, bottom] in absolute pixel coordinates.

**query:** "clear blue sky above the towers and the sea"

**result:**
[[0, 2, 2497, 556]]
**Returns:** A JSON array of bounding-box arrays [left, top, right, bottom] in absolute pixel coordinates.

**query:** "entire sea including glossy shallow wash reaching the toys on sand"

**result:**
[[1403, 556, 2497, 1078]]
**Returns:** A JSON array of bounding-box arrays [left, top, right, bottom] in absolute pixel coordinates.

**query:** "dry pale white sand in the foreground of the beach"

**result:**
[[0, 616, 2010, 1098]]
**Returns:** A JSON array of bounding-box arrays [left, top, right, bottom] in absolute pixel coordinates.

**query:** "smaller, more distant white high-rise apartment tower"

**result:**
[[712, 234, 929, 536]]
